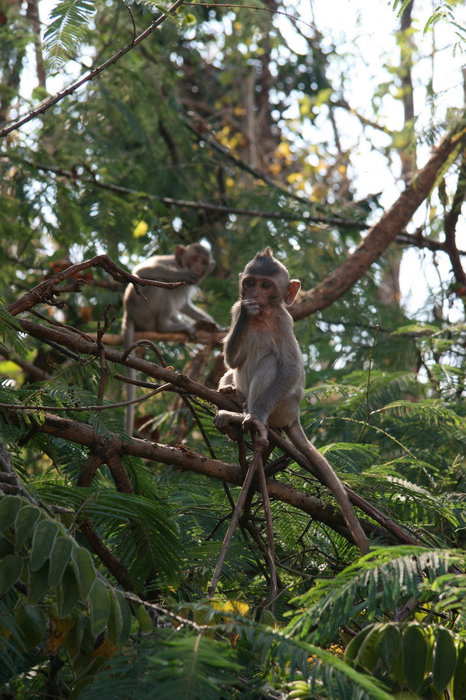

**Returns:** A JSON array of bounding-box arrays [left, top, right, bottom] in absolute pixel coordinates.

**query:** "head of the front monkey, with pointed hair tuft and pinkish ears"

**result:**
[[240, 246, 301, 306]]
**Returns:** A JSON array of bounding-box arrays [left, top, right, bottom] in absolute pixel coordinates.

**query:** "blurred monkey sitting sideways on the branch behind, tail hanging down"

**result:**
[[121, 243, 221, 435]]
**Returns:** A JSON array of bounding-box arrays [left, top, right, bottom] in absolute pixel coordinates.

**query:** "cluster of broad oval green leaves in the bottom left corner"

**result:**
[[0, 495, 131, 684]]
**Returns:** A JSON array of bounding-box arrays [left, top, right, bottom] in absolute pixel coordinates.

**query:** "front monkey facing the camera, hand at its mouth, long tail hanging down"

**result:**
[[214, 247, 368, 551]]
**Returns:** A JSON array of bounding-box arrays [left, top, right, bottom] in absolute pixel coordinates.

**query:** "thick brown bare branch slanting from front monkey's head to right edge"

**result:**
[[290, 125, 466, 321]]
